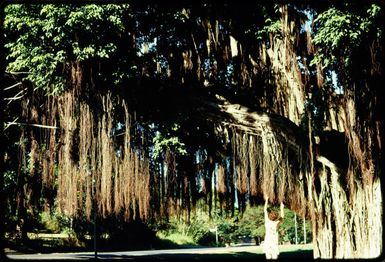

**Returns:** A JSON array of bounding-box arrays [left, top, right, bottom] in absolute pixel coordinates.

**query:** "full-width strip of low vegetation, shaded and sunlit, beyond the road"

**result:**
[[7, 206, 312, 252]]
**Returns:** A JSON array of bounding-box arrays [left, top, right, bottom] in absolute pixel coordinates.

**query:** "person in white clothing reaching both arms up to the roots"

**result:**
[[263, 197, 284, 259]]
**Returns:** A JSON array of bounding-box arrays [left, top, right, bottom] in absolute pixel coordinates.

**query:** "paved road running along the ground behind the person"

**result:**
[[7, 245, 310, 261]]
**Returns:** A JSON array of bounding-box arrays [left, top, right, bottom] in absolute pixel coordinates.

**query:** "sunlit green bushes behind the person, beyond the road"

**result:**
[[154, 205, 311, 246]]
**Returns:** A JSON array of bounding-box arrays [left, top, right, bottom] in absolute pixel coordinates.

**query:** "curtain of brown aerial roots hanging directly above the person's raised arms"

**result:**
[[226, 126, 307, 214]]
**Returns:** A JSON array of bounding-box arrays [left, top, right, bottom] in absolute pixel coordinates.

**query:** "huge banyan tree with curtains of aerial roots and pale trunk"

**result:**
[[2, 1, 384, 258]]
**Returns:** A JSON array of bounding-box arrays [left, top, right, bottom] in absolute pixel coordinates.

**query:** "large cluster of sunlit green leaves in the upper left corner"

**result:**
[[4, 4, 130, 94]]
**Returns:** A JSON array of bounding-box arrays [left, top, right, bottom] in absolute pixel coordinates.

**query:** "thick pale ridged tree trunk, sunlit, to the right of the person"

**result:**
[[312, 157, 382, 258]]
